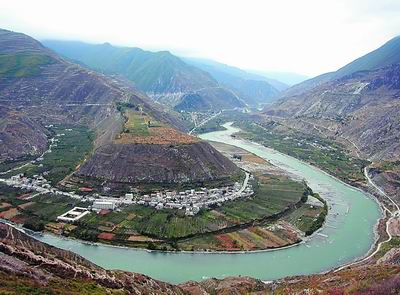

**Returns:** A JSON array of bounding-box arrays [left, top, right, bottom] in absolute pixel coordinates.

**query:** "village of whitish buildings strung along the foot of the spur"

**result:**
[[0, 172, 254, 223]]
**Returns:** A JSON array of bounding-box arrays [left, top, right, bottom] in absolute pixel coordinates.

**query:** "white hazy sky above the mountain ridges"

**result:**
[[0, 0, 400, 76]]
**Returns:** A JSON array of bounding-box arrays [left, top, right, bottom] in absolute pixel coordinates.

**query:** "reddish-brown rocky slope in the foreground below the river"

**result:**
[[0, 224, 400, 295]]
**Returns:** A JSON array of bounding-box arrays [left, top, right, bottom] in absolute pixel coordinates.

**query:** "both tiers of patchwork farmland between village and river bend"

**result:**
[[61, 170, 309, 250]]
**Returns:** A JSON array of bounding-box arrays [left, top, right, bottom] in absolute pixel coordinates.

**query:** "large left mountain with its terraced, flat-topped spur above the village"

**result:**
[[0, 30, 238, 184]]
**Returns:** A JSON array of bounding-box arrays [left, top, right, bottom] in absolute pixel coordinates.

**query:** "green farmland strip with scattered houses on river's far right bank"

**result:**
[[191, 111, 368, 183]]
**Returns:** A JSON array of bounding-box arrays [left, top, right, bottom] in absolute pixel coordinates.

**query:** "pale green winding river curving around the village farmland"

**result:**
[[32, 124, 381, 283]]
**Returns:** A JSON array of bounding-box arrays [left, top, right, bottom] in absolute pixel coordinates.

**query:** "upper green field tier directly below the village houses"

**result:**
[[73, 175, 308, 245]]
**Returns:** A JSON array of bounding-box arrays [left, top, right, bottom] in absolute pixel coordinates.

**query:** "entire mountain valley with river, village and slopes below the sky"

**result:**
[[0, 22, 400, 294]]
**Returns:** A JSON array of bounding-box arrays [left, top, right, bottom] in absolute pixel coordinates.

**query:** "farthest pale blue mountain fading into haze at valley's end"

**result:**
[[184, 58, 288, 106]]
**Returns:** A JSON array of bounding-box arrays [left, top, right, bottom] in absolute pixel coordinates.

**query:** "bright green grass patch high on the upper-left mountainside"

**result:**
[[0, 53, 54, 78]]
